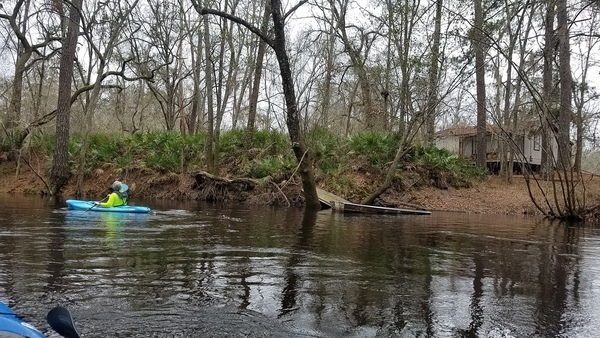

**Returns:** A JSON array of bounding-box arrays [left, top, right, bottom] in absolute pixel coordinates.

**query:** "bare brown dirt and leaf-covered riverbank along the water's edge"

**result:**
[[0, 161, 600, 215]]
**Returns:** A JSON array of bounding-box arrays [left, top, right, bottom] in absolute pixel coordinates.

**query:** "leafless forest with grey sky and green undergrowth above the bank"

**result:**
[[0, 0, 600, 217]]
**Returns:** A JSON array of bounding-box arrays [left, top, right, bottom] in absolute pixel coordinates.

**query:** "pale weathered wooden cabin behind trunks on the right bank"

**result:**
[[435, 125, 558, 173]]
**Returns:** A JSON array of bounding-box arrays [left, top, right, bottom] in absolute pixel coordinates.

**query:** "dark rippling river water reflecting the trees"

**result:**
[[0, 195, 600, 338]]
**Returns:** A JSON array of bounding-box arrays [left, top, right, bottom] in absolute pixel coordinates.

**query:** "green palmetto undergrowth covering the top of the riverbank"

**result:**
[[30, 128, 485, 192]]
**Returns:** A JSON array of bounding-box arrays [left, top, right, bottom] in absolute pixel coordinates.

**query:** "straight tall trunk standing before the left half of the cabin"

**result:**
[[473, 0, 487, 168]]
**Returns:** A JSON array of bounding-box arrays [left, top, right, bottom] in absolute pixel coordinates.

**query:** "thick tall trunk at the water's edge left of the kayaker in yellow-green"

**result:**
[[50, 0, 82, 196]]
